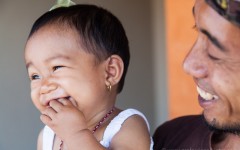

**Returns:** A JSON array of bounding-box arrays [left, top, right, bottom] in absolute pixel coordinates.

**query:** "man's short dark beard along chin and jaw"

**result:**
[[202, 115, 240, 136]]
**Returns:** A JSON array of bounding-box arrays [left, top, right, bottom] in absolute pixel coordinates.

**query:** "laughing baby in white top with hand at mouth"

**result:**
[[25, 2, 152, 150]]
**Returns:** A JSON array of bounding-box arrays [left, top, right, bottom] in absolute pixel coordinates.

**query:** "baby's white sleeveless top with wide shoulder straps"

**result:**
[[43, 109, 153, 150]]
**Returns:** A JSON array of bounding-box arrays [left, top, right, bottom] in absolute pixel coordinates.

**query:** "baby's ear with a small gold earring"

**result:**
[[105, 55, 124, 86]]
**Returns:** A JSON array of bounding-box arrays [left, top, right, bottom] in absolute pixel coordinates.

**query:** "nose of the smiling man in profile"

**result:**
[[183, 49, 208, 78]]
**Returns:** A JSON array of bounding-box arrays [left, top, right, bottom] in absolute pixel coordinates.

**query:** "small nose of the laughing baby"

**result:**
[[40, 78, 58, 94]]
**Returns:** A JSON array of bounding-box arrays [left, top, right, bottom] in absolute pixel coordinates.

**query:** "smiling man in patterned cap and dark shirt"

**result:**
[[154, 0, 240, 150]]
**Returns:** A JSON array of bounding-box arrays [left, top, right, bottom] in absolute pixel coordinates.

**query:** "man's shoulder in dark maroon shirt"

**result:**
[[153, 115, 211, 149]]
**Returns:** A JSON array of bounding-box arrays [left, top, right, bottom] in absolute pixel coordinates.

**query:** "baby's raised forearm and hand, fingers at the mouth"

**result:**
[[41, 99, 105, 150]]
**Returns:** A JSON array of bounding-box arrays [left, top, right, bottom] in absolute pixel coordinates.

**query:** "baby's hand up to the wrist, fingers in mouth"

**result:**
[[40, 99, 87, 141]]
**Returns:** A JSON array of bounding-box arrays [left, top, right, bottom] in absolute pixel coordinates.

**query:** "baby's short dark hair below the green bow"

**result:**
[[28, 4, 130, 93]]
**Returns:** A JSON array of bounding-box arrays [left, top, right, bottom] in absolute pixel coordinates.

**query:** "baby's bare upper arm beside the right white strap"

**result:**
[[111, 115, 151, 150]]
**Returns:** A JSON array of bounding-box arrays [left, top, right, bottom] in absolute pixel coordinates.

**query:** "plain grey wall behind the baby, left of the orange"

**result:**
[[0, 0, 167, 150]]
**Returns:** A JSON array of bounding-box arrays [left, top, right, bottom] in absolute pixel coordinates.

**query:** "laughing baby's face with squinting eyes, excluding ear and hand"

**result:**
[[25, 27, 107, 117]]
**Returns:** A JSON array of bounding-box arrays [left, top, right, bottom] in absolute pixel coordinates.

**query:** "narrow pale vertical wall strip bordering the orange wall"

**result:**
[[151, 0, 168, 129]]
